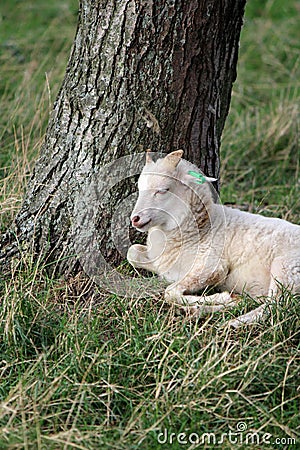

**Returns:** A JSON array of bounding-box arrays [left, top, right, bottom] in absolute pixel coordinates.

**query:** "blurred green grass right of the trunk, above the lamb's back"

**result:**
[[221, 0, 300, 223]]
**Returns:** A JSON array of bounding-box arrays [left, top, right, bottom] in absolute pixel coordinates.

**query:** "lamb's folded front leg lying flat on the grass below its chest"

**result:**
[[165, 283, 237, 316]]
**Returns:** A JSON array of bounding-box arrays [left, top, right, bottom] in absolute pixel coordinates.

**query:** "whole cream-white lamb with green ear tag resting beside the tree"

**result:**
[[127, 150, 300, 328]]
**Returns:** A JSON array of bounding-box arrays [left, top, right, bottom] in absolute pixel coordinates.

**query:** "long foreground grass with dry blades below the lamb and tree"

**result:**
[[0, 264, 299, 449]]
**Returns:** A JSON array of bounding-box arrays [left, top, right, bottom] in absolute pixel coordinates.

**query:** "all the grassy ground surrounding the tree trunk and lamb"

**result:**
[[0, 0, 300, 450]]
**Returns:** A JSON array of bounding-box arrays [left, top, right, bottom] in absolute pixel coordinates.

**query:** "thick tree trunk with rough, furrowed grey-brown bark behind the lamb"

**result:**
[[1, 0, 245, 273]]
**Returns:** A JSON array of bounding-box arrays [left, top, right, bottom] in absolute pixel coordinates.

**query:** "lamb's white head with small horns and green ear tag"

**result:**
[[131, 150, 213, 232]]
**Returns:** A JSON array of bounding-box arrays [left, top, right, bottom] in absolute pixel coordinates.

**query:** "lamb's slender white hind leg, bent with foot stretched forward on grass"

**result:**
[[227, 258, 288, 328]]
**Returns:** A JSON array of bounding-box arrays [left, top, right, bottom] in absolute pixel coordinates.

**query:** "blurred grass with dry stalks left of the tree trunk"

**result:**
[[0, 0, 78, 232]]
